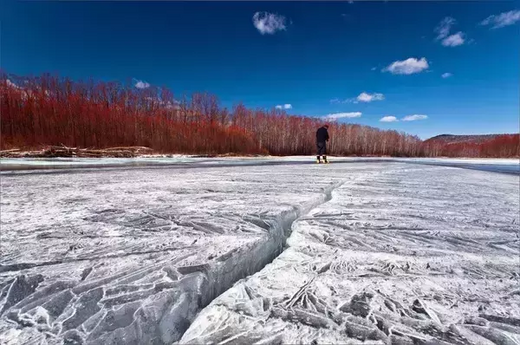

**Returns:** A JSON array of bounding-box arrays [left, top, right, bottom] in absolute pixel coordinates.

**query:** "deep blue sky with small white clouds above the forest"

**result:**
[[0, 0, 520, 138]]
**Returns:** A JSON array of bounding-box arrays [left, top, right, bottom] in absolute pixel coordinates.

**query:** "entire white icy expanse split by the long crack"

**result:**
[[0, 158, 520, 344]]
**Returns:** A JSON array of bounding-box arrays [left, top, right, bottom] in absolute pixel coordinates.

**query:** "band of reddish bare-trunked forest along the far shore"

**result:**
[[0, 73, 519, 157]]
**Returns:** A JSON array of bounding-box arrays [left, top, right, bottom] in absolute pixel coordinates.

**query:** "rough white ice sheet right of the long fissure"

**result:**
[[181, 165, 520, 344]]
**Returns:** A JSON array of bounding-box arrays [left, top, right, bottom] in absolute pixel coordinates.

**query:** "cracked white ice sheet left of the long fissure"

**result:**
[[0, 163, 340, 344]]
